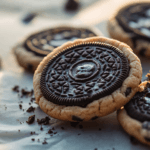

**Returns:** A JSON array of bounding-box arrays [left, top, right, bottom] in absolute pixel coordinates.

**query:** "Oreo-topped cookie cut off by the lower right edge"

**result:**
[[118, 74, 150, 145]]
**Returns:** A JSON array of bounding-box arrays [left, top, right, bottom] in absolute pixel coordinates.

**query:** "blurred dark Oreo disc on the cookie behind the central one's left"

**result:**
[[24, 27, 96, 56]]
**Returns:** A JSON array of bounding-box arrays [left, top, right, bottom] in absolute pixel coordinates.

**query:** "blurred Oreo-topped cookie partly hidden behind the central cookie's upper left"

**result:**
[[13, 26, 101, 72]]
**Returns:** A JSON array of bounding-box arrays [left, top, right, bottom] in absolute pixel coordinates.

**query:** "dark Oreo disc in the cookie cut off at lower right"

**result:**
[[125, 83, 150, 122]]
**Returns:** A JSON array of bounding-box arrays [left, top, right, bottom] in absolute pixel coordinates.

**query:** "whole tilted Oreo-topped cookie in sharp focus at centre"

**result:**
[[33, 37, 142, 121]]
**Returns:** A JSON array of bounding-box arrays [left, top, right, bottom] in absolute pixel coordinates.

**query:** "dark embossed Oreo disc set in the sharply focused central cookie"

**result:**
[[40, 43, 129, 106]]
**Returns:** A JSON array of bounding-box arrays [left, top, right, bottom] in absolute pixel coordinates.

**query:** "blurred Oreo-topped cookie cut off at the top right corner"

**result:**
[[108, 3, 150, 57]]
